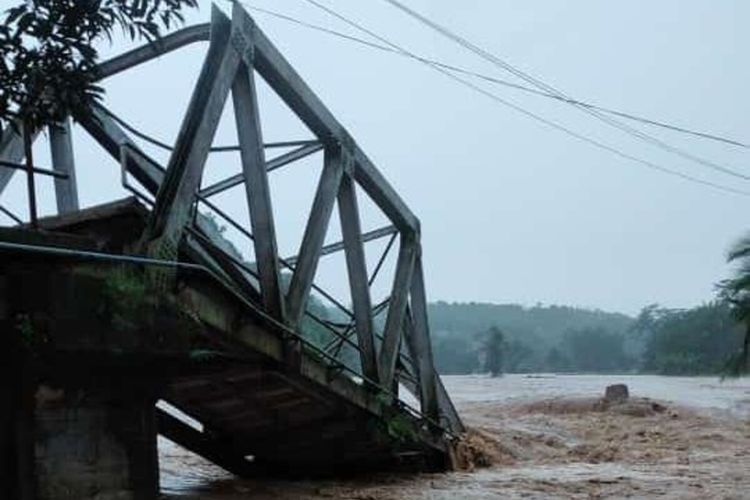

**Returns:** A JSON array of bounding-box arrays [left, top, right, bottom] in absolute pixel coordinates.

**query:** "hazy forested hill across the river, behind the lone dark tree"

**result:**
[[429, 302, 640, 374]]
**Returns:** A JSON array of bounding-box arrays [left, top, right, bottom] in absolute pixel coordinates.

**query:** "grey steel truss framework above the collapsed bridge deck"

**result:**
[[0, 3, 463, 433]]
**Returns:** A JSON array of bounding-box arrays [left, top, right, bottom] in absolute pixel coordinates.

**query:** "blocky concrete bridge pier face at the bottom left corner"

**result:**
[[34, 378, 159, 500]]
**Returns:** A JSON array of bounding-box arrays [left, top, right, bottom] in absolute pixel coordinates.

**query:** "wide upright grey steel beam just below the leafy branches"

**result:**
[[49, 118, 79, 214]]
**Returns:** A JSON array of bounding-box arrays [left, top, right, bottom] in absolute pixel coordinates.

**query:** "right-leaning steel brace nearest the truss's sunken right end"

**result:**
[[378, 233, 418, 387]]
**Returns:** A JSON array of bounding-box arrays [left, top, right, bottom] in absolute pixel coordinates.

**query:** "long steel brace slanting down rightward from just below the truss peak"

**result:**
[[232, 63, 286, 321]]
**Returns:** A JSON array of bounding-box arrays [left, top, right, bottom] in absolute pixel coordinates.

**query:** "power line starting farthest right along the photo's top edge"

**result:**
[[378, 0, 750, 180]]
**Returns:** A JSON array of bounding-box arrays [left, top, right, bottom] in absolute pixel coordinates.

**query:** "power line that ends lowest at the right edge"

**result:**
[[296, 0, 750, 196]]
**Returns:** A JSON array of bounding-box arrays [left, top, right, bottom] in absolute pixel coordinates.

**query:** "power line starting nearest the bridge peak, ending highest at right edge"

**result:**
[[243, 3, 750, 149]]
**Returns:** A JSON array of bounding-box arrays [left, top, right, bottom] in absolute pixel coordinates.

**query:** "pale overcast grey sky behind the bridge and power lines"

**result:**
[[3, 0, 750, 313]]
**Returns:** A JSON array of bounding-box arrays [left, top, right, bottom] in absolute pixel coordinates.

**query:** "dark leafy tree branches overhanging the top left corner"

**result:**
[[0, 0, 197, 134]]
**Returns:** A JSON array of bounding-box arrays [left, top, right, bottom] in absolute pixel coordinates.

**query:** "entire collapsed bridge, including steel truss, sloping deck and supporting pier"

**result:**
[[0, 3, 463, 499]]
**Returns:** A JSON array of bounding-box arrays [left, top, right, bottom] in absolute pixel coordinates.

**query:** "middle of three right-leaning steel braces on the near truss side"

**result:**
[[287, 144, 345, 327]]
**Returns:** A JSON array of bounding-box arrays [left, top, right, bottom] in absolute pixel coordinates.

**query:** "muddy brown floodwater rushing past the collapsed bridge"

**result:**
[[159, 374, 750, 500]]
